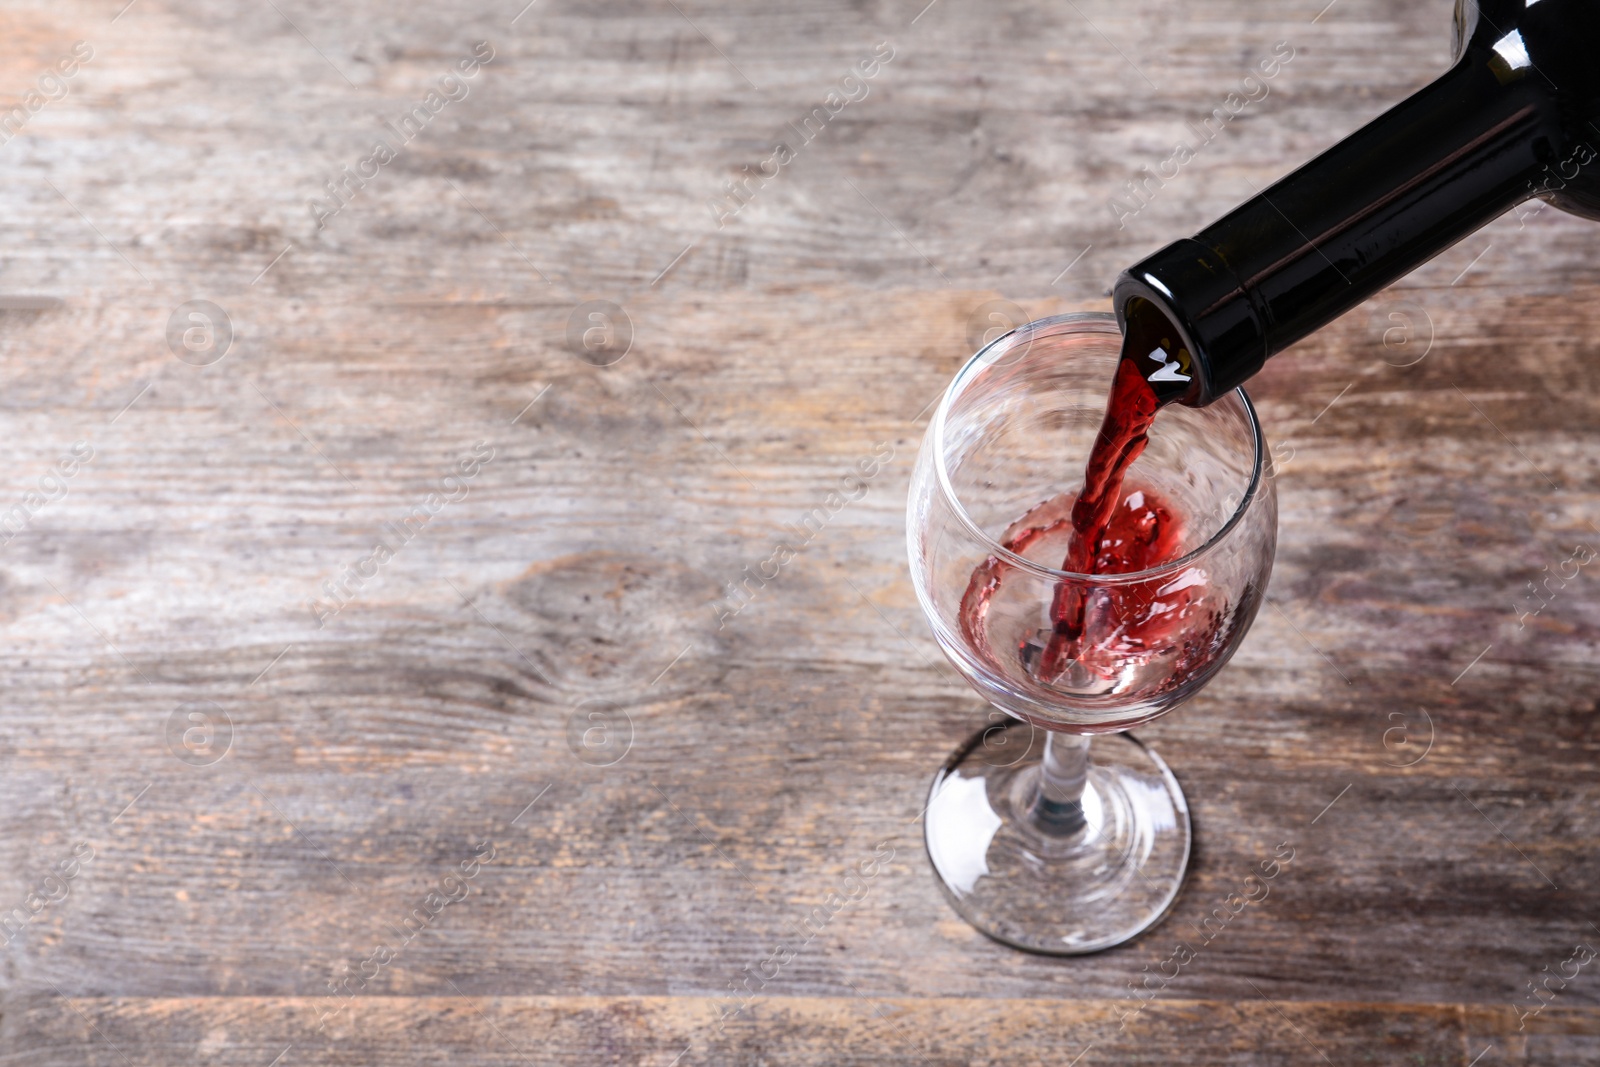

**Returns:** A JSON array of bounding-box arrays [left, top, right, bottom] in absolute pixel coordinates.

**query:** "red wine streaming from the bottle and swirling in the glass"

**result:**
[[957, 302, 1258, 713]]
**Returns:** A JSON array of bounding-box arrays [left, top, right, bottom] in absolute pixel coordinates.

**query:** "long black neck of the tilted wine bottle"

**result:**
[[1114, 40, 1566, 405]]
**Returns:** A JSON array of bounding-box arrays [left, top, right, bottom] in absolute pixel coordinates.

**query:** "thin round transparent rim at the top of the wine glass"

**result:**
[[930, 312, 1266, 585]]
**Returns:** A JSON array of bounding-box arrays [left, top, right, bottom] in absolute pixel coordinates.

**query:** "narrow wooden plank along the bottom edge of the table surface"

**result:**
[[10, 993, 1600, 1067]]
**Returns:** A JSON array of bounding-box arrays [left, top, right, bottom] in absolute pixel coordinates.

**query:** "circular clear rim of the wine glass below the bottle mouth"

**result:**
[[930, 312, 1267, 585]]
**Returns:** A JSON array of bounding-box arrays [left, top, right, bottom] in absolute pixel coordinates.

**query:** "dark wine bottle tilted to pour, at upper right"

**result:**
[[1112, 0, 1600, 406]]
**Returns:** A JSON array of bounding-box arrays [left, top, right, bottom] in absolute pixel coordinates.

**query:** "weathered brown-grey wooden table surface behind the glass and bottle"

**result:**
[[0, 0, 1600, 1067]]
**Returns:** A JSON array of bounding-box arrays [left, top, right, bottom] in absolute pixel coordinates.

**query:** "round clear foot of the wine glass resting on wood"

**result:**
[[923, 720, 1190, 955]]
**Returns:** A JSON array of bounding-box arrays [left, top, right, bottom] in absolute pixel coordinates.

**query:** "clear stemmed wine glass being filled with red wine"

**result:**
[[906, 314, 1277, 955]]
